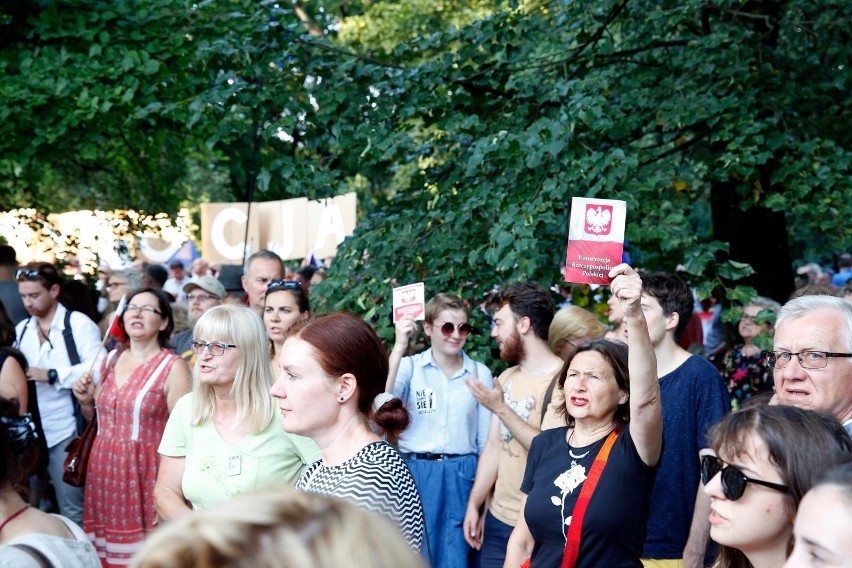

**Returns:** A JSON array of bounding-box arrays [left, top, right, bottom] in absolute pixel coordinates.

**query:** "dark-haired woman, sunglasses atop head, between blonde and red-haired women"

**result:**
[[263, 280, 311, 377]]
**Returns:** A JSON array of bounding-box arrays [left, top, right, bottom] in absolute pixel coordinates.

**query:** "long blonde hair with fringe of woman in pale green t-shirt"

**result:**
[[192, 304, 275, 434]]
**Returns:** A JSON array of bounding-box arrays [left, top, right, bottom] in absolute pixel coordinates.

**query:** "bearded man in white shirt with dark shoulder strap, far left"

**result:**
[[15, 262, 105, 524]]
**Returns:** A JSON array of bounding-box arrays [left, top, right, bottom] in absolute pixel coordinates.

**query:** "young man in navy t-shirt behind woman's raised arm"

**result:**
[[642, 274, 730, 568]]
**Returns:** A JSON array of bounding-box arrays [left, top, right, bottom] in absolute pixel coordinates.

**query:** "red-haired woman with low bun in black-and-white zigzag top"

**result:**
[[271, 312, 423, 550]]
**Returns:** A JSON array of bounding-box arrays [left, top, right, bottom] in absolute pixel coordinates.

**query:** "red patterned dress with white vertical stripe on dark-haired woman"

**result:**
[[83, 349, 178, 566]]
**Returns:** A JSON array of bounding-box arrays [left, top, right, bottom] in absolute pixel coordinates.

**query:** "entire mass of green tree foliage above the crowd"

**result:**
[[0, 0, 852, 360]]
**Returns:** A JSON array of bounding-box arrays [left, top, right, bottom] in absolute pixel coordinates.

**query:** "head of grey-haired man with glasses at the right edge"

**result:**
[[767, 296, 852, 434]]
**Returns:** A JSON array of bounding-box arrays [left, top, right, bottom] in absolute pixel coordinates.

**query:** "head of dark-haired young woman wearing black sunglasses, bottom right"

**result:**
[[701, 406, 852, 568]]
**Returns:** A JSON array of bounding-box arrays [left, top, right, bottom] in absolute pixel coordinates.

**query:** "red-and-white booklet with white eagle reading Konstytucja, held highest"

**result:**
[[564, 197, 627, 284]]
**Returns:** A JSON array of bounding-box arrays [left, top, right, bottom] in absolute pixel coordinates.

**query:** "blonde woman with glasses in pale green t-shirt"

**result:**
[[154, 305, 320, 520]]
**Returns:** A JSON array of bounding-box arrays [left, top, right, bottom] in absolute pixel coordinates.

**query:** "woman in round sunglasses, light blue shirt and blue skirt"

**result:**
[[385, 294, 494, 567]]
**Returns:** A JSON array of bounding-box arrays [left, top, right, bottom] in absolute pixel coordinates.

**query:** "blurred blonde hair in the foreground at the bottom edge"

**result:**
[[132, 488, 425, 568]]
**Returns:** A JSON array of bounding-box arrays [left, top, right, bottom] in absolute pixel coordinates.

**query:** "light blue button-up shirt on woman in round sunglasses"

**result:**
[[393, 349, 494, 454]]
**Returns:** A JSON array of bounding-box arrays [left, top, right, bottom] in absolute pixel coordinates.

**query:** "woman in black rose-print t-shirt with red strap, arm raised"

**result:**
[[505, 264, 666, 568]]
